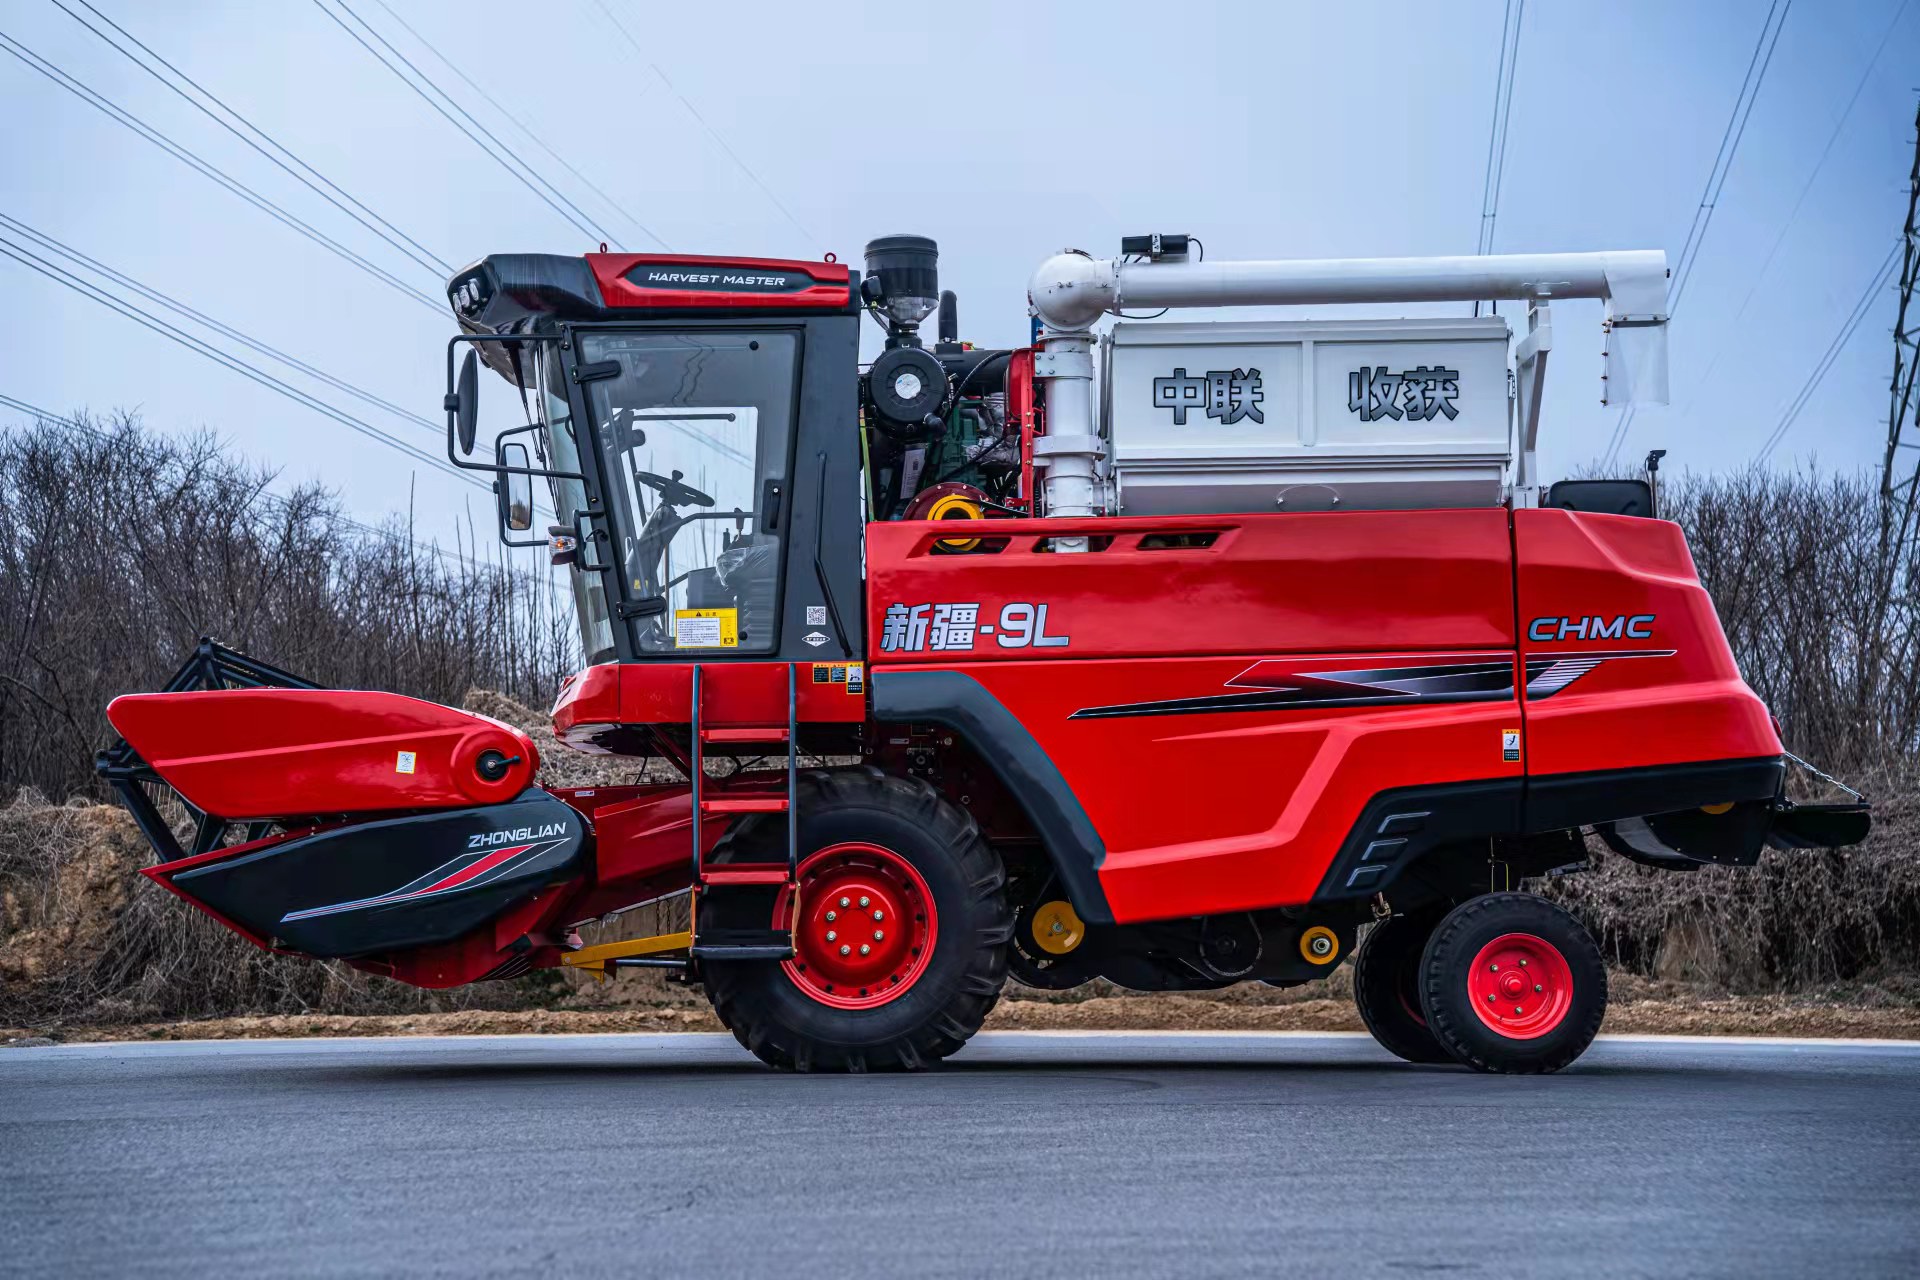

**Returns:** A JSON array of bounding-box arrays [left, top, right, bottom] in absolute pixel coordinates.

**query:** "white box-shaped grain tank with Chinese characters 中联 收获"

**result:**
[[1100, 317, 1511, 516]]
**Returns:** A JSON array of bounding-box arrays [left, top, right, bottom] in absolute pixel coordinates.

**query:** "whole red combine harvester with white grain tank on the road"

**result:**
[[100, 236, 1868, 1071]]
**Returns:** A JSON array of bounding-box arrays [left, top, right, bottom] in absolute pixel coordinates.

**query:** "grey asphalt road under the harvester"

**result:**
[[0, 1032, 1920, 1280]]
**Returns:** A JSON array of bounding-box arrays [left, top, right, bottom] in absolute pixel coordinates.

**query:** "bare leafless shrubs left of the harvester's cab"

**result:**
[[0, 416, 576, 796]]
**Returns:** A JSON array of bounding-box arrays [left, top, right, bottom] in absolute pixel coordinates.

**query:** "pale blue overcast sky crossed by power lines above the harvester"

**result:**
[[0, 0, 1920, 541]]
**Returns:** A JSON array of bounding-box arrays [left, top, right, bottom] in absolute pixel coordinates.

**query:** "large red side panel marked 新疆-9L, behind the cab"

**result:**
[[868, 509, 1523, 923]]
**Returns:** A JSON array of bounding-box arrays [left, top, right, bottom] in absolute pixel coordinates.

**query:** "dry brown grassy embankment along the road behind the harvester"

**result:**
[[11, 693, 1920, 1042]]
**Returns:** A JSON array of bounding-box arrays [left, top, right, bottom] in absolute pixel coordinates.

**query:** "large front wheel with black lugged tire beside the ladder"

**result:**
[[701, 770, 1014, 1071]]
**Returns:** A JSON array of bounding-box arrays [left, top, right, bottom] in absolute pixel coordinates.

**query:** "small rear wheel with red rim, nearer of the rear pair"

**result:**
[[1421, 892, 1607, 1075]]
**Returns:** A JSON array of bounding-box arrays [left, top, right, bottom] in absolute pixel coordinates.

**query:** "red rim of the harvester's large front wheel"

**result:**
[[774, 842, 939, 1009]]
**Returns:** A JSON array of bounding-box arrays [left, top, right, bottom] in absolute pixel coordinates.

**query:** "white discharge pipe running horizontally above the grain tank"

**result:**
[[1027, 249, 1667, 529]]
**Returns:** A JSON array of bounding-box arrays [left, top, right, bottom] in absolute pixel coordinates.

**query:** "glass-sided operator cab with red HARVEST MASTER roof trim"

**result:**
[[447, 253, 860, 664]]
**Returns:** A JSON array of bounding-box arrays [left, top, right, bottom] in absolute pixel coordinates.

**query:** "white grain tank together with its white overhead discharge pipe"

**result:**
[[1027, 247, 1667, 529]]
